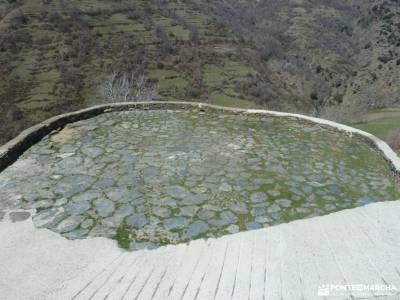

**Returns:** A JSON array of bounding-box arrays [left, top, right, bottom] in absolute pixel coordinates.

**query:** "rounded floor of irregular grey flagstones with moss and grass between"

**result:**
[[0, 110, 400, 249]]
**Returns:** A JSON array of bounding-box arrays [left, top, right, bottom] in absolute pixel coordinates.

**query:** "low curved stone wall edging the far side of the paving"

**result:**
[[0, 101, 400, 175]]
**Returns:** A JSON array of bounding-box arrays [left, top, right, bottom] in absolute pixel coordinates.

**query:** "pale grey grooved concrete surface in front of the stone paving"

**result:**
[[0, 201, 400, 300]]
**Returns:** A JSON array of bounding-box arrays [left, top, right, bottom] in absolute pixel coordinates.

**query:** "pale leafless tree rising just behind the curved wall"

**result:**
[[101, 72, 158, 103]]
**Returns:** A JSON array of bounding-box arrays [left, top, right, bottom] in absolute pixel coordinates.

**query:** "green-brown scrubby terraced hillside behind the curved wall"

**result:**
[[0, 0, 400, 143]]
